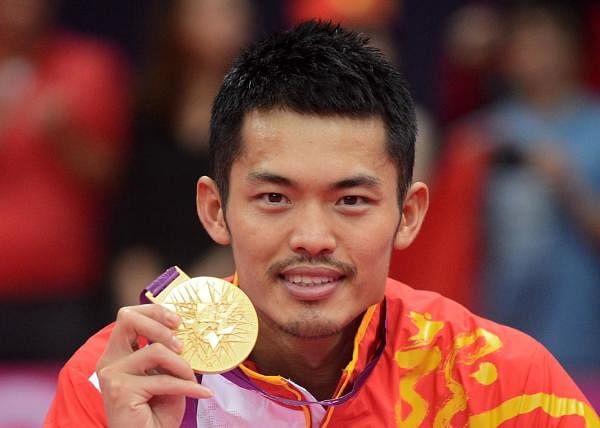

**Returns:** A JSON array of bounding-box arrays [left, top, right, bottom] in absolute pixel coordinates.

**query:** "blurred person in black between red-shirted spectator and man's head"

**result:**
[[113, 0, 253, 306]]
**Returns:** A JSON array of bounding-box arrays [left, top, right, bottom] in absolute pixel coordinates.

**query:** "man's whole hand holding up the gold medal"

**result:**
[[97, 305, 212, 428]]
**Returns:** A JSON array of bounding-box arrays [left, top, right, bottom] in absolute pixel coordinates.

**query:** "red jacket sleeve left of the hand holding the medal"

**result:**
[[44, 325, 113, 428]]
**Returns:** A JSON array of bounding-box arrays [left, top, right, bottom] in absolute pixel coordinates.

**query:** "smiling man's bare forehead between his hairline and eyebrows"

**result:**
[[239, 110, 391, 171]]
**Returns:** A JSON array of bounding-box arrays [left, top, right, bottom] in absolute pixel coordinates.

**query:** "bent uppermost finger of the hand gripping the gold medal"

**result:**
[[103, 304, 182, 362]]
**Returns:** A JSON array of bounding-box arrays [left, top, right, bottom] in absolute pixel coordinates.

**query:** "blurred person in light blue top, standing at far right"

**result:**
[[484, 5, 600, 369]]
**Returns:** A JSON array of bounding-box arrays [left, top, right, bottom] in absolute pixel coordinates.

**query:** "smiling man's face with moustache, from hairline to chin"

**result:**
[[226, 110, 400, 338]]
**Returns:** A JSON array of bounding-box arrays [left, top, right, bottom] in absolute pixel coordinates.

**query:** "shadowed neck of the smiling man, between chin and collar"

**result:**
[[251, 316, 362, 400]]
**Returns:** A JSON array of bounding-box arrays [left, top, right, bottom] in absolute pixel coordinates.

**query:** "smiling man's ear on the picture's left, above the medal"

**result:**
[[196, 176, 231, 245]]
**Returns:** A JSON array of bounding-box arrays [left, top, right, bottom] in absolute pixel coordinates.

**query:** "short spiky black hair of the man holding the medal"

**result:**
[[209, 20, 416, 205]]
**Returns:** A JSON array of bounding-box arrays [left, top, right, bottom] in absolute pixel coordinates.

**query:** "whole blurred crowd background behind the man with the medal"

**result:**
[[0, 0, 600, 427]]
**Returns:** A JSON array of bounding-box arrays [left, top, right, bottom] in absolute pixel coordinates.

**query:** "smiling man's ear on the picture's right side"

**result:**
[[394, 182, 429, 250]]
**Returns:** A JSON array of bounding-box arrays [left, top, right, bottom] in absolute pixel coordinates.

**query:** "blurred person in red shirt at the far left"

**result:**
[[0, 0, 128, 359]]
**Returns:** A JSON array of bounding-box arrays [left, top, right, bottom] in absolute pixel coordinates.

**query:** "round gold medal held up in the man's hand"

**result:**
[[146, 270, 258, 373]]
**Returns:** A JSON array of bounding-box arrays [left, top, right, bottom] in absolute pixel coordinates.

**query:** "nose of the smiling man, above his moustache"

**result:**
[[290, 203, 336, 256]]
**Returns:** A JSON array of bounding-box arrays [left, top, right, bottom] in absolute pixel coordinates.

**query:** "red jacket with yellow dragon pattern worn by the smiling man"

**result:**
[[45, 279, 600, 428]]
